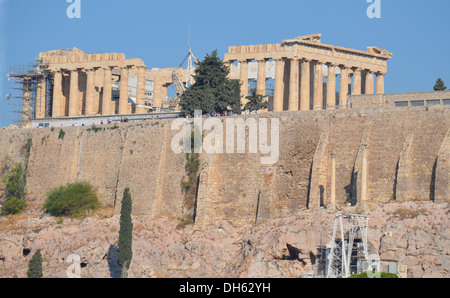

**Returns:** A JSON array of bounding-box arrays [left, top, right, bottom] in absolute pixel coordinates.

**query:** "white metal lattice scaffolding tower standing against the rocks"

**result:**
[[327, 214, 370, 278]]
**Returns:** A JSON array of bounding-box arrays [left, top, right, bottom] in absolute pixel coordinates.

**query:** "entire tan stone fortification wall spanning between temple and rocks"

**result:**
[[0, 108, 450, 229]]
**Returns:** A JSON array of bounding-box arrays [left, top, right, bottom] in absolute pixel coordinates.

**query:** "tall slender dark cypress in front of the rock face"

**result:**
[[118, 188, 133, 276]]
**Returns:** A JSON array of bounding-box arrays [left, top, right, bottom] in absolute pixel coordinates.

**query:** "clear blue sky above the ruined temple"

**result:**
[[0, 0, 450, 126]]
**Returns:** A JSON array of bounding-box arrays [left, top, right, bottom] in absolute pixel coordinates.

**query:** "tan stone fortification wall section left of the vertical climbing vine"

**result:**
[[0, 121, 184, 216]]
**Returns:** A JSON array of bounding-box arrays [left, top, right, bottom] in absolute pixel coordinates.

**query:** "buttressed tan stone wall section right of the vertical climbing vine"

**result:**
[[196, 109, 450, 228]]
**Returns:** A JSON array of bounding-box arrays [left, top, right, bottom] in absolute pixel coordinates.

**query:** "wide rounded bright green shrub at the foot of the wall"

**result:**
[[44, 182, 100, 217]]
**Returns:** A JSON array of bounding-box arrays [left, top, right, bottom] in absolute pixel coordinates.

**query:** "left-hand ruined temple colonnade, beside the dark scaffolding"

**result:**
[[30, 48, 188, 119]]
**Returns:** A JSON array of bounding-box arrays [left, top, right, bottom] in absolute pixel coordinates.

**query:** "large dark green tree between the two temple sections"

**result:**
[[180, 50, 241, 115]]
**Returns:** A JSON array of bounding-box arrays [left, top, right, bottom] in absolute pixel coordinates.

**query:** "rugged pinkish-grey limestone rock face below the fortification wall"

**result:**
[[0, 202, 450, 278]]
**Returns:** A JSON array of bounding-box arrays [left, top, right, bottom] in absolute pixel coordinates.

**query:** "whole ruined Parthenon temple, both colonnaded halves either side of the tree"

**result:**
[[9, 34, 393, 123]]
